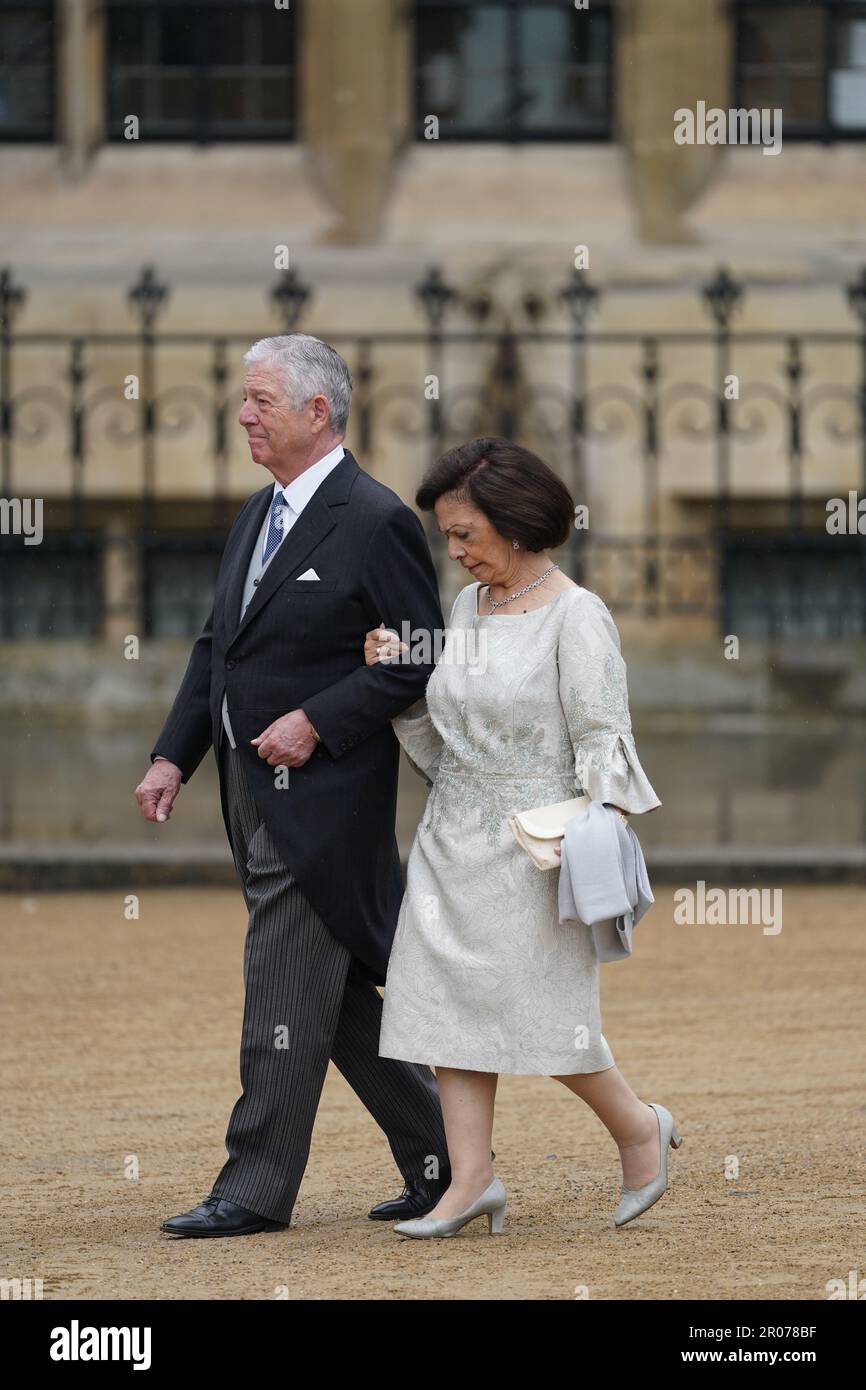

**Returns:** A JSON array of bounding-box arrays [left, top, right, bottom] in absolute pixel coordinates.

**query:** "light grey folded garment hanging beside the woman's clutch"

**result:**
[[559, 801, 655, 960]]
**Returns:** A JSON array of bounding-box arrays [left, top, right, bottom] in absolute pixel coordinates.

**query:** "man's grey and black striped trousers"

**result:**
[[213, 737, 449, 1222]]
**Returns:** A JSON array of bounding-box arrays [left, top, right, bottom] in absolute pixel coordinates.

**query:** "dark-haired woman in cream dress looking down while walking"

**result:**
[[364, 439, 680, 1237]]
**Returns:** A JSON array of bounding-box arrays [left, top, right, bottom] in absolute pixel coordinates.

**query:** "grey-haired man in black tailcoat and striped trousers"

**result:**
[[136, 334, 449, 1236]]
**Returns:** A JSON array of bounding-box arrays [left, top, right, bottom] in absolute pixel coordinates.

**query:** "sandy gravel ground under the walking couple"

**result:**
[[0, 885, 866, 1300]]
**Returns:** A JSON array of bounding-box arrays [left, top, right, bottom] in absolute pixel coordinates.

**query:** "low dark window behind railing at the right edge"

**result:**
[[721, 535, 866, 638]]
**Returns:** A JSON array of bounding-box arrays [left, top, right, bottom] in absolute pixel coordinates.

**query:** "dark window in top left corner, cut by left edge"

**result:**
[[0, 0, 54, 140]]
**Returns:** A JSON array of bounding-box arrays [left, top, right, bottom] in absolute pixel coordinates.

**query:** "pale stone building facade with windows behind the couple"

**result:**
[[0, 0, 866, 639]]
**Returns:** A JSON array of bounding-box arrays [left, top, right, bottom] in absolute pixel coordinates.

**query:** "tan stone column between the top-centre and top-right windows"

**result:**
[[614, 0, 734, 242]]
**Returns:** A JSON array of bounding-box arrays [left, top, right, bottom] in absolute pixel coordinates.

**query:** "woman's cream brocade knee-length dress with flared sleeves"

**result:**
[[379, 584, 660, 1076]]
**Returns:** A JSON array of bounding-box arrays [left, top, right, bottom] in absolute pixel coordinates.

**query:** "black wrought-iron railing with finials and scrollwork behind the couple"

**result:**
[[0, 267, 866, 635]]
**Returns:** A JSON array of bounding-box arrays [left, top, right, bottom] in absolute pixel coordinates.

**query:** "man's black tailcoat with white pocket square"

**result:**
[[152, 450, 443, 984]]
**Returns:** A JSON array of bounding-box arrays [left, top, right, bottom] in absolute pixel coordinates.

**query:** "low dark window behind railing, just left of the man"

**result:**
[[145, 534, 225, 637]]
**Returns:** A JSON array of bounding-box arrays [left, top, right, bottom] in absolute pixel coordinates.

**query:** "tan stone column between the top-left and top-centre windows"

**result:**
[[297, 0, 413, 243]]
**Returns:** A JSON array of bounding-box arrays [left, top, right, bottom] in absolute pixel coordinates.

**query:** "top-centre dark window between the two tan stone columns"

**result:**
[[416, 0, 612, 140]]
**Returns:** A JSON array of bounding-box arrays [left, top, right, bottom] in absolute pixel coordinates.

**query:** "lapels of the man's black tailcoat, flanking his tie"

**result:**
[[228, 449, 359, 642]]
